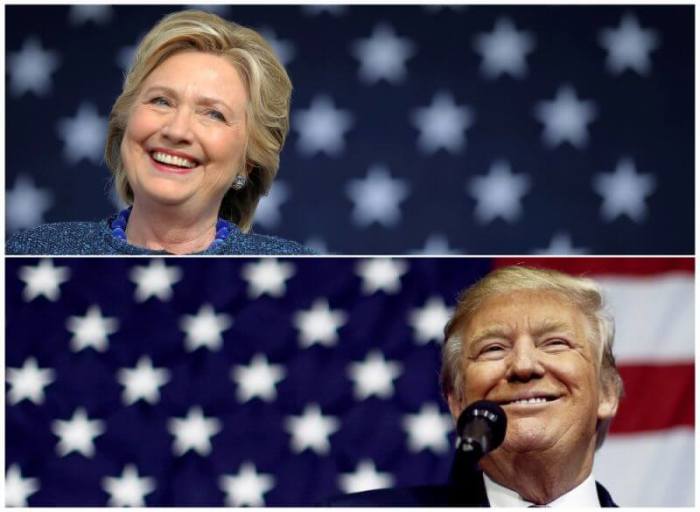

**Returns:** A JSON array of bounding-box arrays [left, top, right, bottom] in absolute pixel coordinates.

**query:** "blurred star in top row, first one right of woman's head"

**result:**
[[351, 23, 416, 84]]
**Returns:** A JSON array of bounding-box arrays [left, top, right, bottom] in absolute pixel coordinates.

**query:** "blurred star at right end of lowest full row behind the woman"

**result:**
[[593, 158, 656, 222]]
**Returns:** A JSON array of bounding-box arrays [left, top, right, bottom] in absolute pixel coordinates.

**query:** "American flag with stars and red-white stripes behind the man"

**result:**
[[5, 258, 695, 506]]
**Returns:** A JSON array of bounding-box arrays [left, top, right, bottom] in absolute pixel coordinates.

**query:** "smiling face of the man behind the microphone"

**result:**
[[450, 291, 617, 456]]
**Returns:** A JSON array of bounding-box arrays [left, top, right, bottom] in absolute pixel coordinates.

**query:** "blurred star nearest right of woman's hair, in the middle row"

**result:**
[[293, 95, 353, 156]]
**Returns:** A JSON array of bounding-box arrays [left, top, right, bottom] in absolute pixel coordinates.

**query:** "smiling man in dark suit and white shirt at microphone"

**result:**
[[333, 266, 622, 507]]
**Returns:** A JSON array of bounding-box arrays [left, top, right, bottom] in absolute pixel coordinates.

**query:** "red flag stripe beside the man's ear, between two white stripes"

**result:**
[[610, 362, 695, 434]]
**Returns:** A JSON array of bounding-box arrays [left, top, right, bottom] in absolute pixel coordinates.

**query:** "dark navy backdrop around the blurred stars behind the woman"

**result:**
[[5, 5, 694, 254]]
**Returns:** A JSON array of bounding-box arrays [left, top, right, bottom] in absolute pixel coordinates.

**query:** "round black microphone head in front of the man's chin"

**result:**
[[457, 400, 507, 455]]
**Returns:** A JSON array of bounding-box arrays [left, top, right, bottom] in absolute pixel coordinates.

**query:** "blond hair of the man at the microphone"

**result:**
[[440, 265, 623, 446]]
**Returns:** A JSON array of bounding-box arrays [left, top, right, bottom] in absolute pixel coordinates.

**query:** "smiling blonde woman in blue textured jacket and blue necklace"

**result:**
[[7, 11, 311, 254]]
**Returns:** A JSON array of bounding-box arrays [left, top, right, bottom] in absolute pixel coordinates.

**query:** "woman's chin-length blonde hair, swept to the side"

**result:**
[[105, 10, 292, 231]]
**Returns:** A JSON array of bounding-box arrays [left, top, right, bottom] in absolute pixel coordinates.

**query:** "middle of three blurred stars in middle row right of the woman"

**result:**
[[412, 91, 475, 155]]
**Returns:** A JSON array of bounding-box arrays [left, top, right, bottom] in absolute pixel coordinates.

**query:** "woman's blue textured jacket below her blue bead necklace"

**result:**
[[6, 220, 315, 255]]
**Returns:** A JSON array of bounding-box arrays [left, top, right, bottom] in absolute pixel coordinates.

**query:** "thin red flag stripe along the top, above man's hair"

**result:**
[[493, 257, 695, 276]]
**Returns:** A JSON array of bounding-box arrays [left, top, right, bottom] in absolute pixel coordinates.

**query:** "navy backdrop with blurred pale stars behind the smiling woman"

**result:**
[[5, 4, 694, 254]]
